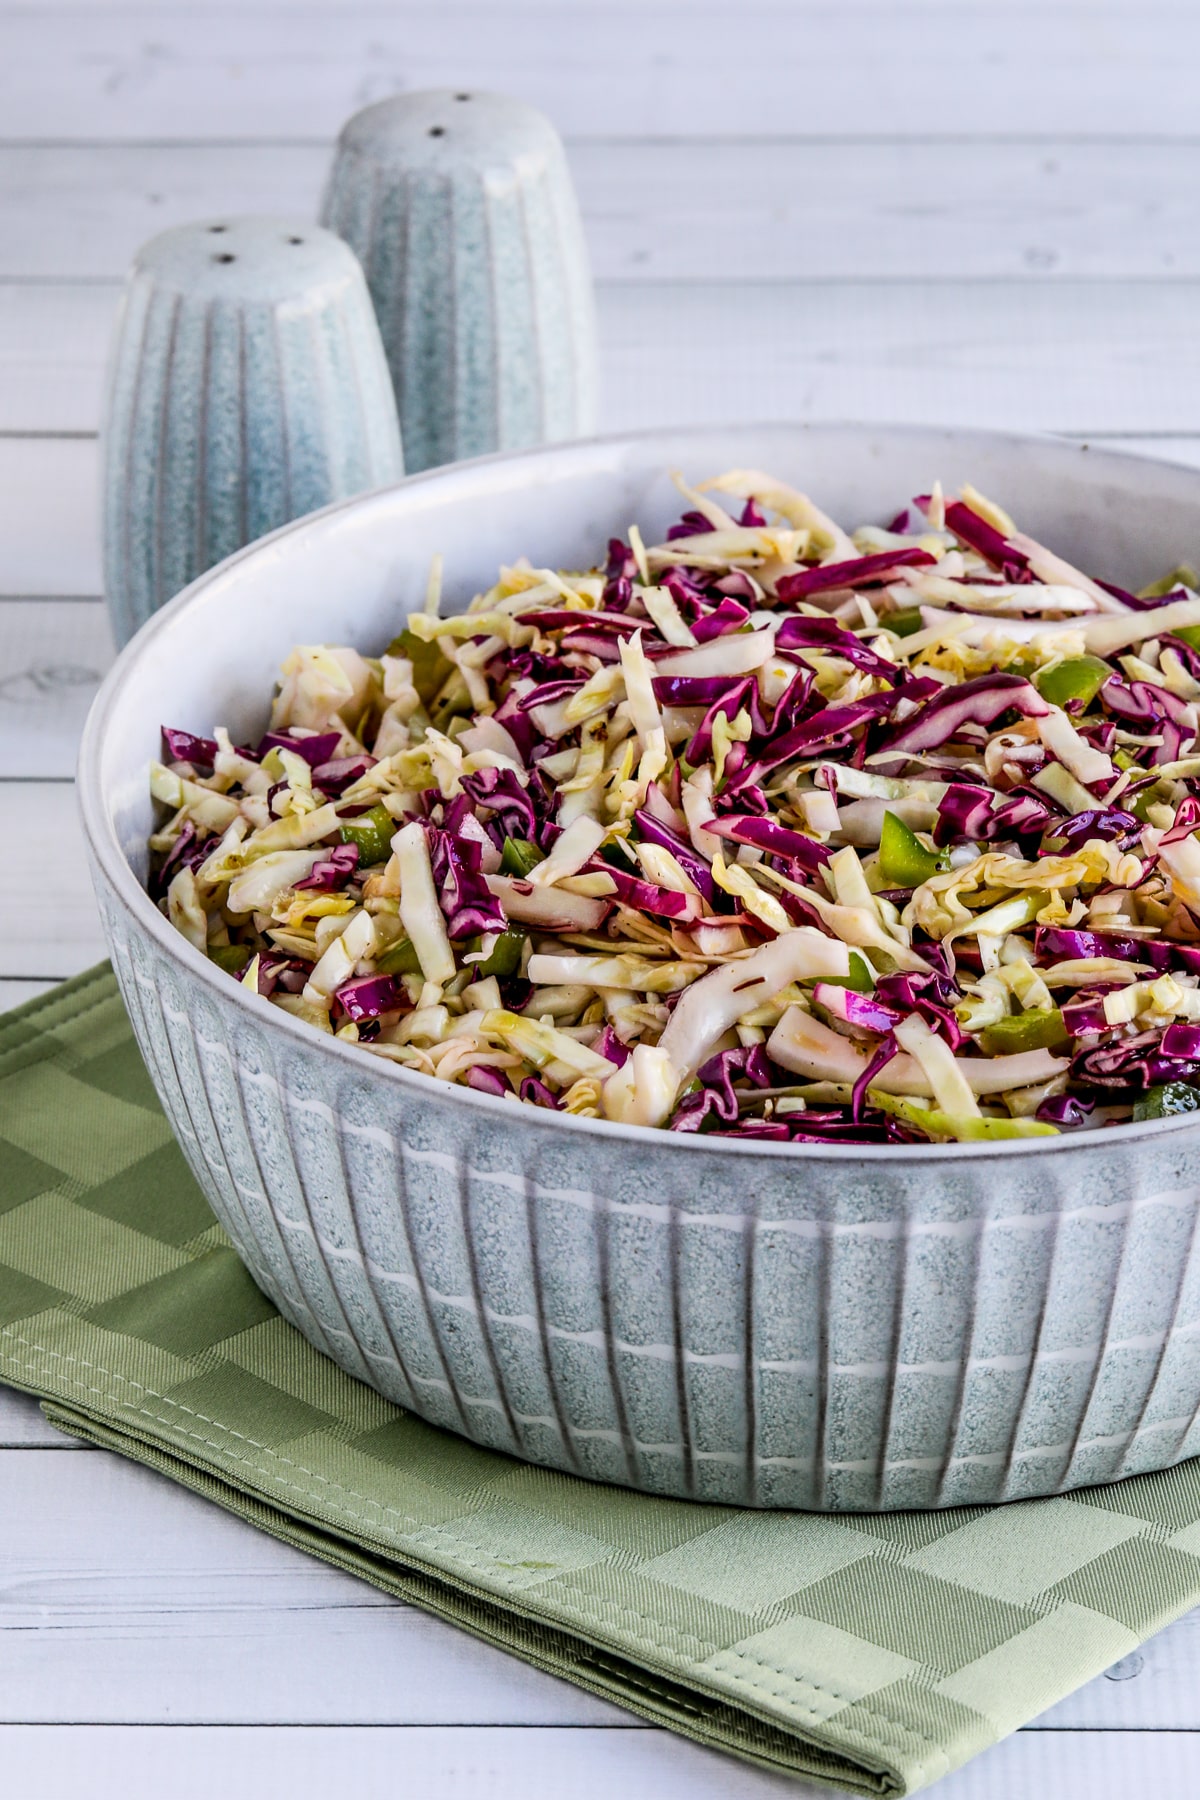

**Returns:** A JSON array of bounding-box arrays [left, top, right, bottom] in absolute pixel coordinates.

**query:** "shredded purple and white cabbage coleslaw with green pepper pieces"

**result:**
[[151, 470, 1200, 1143]]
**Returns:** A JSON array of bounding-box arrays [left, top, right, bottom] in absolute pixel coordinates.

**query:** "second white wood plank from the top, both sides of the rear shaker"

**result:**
[[11, 137, 1200, 281]]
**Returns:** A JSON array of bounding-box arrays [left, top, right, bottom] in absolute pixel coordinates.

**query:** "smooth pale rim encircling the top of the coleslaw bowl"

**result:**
[[76, 419, 1200, 1168]]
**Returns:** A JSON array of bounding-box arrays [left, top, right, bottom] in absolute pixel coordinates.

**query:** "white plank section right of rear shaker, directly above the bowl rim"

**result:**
[[601, 283, 1200, 434]]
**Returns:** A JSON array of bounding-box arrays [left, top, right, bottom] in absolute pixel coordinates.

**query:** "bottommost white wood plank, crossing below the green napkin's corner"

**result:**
[[0, 1726, 1200, 1800]]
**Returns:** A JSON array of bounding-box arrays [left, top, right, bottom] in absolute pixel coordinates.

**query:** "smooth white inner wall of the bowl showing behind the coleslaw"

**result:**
[[79, 425, 1200, 932]]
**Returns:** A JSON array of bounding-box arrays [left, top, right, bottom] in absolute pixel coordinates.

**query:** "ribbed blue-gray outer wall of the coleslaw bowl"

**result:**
[[101, 878, 1200, 1512]]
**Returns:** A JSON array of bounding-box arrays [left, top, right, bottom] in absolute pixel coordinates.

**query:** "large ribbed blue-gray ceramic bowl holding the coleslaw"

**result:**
[[79, 425, 1200, 1512]]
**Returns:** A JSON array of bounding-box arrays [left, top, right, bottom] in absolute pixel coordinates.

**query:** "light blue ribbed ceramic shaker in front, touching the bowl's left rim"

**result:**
[[103, 218, 405, 644]]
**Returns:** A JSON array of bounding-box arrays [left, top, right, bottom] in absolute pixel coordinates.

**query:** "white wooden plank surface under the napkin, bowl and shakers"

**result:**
[[0, 0, 1200, 1800]]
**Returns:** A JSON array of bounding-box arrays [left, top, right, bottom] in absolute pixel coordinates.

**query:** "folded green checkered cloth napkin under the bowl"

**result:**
[[0, 967, 1200, 1795]]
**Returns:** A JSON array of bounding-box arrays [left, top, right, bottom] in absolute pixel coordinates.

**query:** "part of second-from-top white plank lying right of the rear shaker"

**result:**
[[572, 141, 1200, 281]]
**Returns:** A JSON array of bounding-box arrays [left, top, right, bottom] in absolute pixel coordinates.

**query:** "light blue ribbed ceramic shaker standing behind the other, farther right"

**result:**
[[320, 88, 596, 470]]
